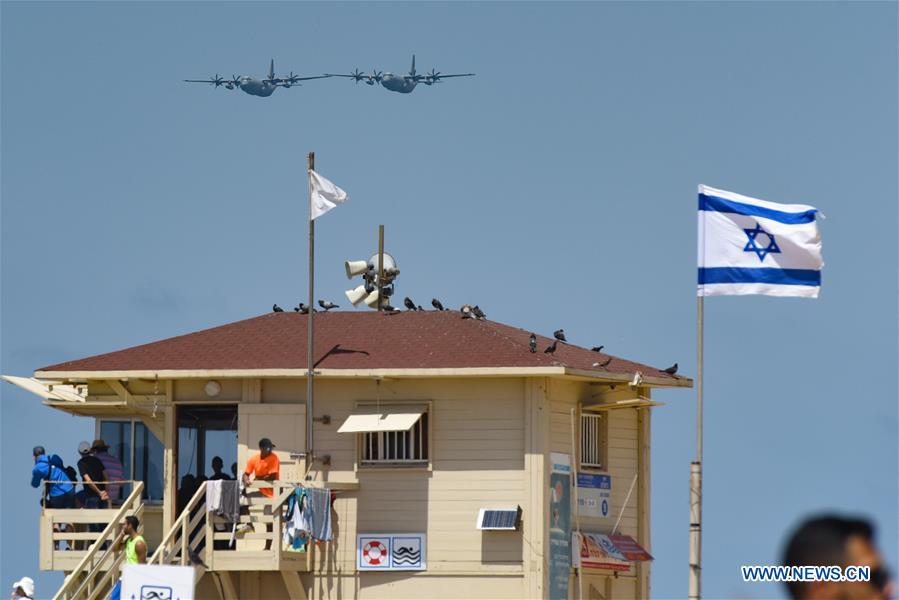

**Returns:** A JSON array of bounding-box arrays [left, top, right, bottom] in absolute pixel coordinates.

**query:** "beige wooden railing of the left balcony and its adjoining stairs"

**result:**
[[51, 481, 144, 600]]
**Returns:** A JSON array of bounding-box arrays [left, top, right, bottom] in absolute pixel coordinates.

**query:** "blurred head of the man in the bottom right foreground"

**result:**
[[781, 515, 893, 600]]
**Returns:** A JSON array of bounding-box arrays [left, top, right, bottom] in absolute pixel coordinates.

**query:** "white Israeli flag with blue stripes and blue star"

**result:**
[[697, 185, 824, 298]]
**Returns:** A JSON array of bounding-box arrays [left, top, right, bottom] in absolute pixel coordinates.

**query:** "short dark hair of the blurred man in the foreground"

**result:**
[[781, 515, 874, 600]]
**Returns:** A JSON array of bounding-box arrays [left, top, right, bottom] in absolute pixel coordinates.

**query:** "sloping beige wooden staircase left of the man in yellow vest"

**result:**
[[53, 481, 144, 600]]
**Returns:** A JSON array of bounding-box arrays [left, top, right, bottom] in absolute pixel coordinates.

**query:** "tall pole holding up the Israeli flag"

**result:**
[[688, 296, 705, 600]]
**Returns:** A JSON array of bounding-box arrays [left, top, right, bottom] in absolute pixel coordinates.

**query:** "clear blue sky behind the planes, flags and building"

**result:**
[[0, 2, 899, 598]]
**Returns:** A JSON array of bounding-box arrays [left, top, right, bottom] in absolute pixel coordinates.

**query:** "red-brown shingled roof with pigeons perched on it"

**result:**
[[38, 311, 677, 381]]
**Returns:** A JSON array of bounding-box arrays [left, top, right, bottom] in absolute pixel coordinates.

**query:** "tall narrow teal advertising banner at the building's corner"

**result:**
[[549, 452, 571, 600]]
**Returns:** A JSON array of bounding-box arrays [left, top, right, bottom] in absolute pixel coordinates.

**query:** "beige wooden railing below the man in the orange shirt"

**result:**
[[147, 481, 310, 571]]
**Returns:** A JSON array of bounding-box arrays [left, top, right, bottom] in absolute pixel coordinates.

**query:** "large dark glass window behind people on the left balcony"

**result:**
[[97, 419, 164, 502]]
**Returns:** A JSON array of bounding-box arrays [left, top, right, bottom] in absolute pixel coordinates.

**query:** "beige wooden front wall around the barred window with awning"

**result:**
[[262, 379, 526, 597]]
